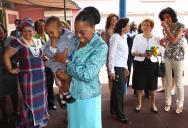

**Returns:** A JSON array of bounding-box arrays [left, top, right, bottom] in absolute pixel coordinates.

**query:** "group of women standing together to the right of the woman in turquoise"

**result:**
[[101, 7, 187, 123]]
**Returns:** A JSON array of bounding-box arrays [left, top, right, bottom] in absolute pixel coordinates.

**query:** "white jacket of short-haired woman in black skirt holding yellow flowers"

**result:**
[[132, 34, 162, 62]]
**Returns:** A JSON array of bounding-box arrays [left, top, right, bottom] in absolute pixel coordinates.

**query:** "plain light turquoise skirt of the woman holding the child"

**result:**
[[67, 95, 102, 128]]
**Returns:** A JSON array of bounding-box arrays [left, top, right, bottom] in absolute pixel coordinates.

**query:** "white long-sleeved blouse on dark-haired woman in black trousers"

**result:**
[[108, 33, 129, 73]]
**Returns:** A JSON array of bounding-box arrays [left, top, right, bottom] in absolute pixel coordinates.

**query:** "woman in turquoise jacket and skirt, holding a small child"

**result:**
[[55, 7, 108, 128]]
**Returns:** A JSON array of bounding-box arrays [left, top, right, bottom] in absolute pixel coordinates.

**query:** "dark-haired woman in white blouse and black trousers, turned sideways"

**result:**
[[108, 18, 129, 123]]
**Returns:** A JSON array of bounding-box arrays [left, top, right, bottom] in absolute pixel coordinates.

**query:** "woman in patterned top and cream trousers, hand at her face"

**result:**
[[159, 7, 185, 114]]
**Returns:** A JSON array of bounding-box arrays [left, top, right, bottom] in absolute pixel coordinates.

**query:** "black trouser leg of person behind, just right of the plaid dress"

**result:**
[[45, 67, 54, 107]]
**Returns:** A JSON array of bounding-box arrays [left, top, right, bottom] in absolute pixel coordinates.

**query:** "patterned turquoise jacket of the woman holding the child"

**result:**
[[67, 33, 108, 99]]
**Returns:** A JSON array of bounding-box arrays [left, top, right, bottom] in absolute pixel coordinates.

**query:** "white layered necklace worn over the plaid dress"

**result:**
[[22, 38, 40, 57]]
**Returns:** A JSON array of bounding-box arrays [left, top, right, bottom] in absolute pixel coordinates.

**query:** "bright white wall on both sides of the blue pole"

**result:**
[[75, 0, 188, 36]]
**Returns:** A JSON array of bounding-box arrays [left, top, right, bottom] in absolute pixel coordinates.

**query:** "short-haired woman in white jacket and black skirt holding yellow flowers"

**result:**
[[132, 19, 160, 113]]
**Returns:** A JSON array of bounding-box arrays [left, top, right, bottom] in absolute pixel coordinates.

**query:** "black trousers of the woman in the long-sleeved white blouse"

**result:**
[[110, 67, 126, 119]]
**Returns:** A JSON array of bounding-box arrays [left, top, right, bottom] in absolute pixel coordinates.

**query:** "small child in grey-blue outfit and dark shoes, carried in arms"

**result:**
[[44, 16, 75, 104]]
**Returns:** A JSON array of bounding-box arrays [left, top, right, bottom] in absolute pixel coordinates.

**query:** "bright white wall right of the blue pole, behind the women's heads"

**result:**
[[127, 0, 188, 36]]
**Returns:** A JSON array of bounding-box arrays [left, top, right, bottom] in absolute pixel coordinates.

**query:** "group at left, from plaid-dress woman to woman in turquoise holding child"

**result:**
[[0, 7, 108, 128]]
